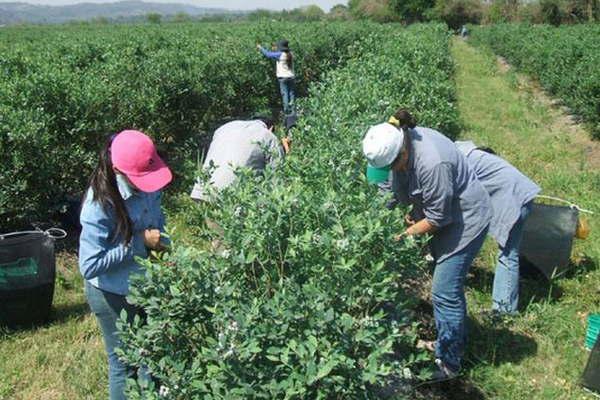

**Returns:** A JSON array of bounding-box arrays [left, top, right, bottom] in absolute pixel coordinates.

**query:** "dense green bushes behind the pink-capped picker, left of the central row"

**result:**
[[0, 22, 378, 229]]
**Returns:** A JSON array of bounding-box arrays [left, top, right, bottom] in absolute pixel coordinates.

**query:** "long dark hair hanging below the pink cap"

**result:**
[[90, 135, 133, 244]]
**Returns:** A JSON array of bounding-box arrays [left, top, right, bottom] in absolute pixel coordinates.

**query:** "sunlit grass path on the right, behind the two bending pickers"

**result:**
[[452, 39, 600, 400]]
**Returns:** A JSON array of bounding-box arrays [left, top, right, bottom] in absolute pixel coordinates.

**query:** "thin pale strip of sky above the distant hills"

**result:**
[[0, 0, 347, 11]]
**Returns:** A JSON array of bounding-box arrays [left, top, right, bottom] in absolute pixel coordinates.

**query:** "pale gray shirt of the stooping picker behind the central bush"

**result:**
[[191, 120, 284, 200]]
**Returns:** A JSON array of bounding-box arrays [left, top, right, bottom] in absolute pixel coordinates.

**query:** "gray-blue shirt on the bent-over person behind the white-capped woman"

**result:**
[[455, 141, 541, 247]]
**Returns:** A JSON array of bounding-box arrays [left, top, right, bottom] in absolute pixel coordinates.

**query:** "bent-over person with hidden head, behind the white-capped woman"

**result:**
[[455, 141, 541, 314]]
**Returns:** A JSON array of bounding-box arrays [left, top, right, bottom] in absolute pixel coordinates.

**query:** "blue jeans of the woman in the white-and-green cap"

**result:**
[[431, 228, 487, 371]]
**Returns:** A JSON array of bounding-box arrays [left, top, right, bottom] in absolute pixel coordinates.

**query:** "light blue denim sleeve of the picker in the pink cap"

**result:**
[[79, 201, 135, 280]]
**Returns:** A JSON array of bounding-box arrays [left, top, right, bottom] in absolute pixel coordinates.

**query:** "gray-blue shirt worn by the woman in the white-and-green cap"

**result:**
[[406, 127, 492, 262]]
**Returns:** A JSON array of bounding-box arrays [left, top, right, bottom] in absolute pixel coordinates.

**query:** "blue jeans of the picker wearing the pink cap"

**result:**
[[85, 281, 149, 400]]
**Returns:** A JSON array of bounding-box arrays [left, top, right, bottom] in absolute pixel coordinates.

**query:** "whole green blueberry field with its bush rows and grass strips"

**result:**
[[0, 15, 600, 400]]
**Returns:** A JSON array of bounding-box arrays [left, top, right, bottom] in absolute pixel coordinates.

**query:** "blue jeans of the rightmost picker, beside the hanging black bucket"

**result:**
[[492, 202, 532, 314]]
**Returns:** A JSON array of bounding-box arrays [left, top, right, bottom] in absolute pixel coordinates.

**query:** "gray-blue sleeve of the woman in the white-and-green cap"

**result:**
[[421, 162, 454, 228]]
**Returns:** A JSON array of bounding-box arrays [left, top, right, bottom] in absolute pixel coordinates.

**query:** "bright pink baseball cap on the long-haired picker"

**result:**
[[110, 130, 173, 193]]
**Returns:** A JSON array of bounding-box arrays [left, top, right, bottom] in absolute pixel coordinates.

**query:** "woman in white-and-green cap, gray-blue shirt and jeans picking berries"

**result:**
[[363, 109, 492, 380]]
